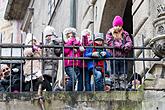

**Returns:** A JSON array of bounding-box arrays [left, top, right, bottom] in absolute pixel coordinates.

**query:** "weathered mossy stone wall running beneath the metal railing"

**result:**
[[0, 91, 165, 110]]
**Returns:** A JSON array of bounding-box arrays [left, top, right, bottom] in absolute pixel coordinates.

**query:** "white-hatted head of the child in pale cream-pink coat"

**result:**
[[25, 33, 37, 45]]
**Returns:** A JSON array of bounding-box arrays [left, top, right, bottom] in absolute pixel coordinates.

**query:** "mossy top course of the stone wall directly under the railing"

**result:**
[[0, 91, 143, 102]]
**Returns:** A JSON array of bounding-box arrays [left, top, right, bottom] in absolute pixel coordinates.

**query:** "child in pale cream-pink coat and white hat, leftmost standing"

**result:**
[[23, 33, 43, 91]]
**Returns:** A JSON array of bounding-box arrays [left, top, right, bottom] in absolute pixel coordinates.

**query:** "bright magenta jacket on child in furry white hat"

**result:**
[[64, 38, 82, 67]]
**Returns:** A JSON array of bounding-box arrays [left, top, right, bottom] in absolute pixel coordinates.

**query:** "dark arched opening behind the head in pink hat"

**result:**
[[99, 0, 133, 33]]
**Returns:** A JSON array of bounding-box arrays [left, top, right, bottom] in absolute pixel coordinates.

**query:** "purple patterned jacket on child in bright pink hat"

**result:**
[[106, 31, 132, 57]]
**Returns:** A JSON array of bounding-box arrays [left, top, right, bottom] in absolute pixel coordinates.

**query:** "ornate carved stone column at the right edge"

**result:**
[[145, 5, 165, 89]]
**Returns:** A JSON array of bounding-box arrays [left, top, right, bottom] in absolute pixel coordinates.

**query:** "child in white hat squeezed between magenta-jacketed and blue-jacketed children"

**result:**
[[81, 29, 93, 91]]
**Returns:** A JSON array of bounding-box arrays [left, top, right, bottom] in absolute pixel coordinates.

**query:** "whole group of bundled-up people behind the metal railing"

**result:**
[[0, 16, 142, 92]]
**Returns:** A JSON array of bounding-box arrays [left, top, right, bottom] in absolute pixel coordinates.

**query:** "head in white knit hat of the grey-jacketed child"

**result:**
[[43, 26, 58, 41]]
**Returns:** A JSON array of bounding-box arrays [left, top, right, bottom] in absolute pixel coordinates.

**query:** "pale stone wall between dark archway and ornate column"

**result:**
[[132, 0, 163, 74]]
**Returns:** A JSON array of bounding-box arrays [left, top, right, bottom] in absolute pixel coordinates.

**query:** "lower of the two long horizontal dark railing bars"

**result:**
[[0, 56, 161, 61]]
